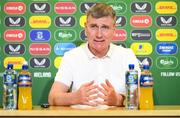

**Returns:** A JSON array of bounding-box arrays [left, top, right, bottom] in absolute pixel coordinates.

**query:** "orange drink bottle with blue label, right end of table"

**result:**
[[139, 64, 154, 110]]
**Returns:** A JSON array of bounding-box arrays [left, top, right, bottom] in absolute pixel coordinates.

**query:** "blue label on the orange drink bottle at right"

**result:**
[[140, 75, 153, 87]]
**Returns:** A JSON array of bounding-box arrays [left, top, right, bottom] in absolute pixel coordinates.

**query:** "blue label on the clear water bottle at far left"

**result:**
[[4, 74, 16, 86]]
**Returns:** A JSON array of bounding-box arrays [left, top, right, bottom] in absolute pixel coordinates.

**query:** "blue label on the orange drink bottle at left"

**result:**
[[18, 74, 32, 86]]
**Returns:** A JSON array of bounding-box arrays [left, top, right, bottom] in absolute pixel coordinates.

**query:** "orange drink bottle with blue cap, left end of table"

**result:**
[[18, 63, 32, 110]]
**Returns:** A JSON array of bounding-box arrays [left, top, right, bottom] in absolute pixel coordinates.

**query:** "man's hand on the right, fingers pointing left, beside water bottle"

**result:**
[[98, 80, 124, 106]]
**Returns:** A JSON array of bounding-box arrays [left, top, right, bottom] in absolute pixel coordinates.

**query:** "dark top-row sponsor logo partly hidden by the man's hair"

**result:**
[[80, 2, 96, 13]]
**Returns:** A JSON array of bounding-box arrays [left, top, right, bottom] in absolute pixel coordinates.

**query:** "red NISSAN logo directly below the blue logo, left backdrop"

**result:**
[[29, 43, 51, 55]]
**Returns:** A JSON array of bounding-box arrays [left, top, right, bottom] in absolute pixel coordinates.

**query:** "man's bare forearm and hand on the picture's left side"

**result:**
[[48, 81, 97, 106]]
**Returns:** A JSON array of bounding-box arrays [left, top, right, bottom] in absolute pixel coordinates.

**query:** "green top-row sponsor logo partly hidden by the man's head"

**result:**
[[108, 2, 127, 15]]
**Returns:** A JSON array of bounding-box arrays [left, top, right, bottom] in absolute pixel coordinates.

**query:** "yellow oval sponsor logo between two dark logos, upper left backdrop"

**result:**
[[29, 16, 51, 28]]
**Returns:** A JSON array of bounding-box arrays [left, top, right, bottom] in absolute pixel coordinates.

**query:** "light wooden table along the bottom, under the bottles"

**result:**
[[0, 105, 180, 118]]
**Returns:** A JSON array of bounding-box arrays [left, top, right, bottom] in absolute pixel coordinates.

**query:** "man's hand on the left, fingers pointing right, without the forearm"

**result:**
[[74, 81, 98, 106]]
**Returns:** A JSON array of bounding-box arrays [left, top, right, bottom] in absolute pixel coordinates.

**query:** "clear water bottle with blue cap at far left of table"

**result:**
[[3, 64, 17, 110]]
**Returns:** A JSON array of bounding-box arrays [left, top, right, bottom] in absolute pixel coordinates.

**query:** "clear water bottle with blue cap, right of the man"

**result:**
[[125, 64, 138, 110]]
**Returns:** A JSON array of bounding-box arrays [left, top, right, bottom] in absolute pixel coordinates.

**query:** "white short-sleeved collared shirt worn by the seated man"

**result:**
[[55, 44, 140, 94]]
